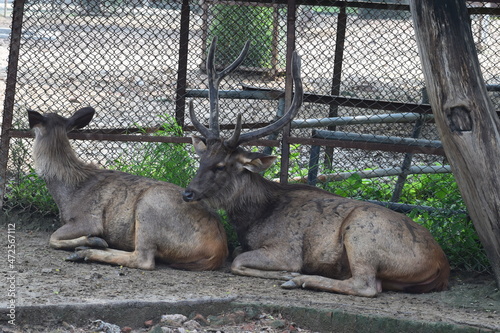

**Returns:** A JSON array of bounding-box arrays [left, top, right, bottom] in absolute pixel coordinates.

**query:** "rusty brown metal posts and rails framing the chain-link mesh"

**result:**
[[0, 0, 500, 209]]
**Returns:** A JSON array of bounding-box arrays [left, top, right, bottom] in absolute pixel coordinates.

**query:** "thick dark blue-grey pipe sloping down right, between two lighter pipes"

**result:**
[[313, 130, 443, 148]]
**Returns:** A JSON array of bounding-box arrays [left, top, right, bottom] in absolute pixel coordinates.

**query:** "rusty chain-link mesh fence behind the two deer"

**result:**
[[0, 0, 500, 226]]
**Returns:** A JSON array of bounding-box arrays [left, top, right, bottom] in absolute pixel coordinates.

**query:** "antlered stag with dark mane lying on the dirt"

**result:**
[[182, 39, 450, 297]]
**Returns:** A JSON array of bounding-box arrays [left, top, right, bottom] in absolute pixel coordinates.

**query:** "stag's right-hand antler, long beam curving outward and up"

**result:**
[[238, 51, 304, 145]]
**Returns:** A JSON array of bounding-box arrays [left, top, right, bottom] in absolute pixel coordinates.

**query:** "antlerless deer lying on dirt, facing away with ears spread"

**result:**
[[28, 107, 228, 270]]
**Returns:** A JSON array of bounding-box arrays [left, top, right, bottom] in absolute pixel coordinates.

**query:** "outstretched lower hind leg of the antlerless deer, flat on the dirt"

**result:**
[[66, 249, 155, 270]]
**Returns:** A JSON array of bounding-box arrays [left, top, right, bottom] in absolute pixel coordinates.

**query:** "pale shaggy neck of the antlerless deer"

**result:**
[[33, 129, 95, 186]]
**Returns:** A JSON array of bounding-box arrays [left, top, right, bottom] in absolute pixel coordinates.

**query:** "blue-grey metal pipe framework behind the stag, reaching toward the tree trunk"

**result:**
[[186, 86, 451, 202]]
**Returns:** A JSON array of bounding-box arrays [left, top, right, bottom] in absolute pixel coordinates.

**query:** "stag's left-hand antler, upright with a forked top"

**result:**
[[189, 37, 250, 139]]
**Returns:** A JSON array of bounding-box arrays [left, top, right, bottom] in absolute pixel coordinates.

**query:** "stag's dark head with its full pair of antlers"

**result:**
[[183, 39, 303, 208]]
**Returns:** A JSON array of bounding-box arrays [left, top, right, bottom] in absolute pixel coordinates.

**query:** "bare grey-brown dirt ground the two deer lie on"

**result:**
[[0, 214, 500, 332]]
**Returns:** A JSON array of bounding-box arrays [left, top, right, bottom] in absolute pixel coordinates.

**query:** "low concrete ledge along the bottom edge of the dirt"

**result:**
[[0, 297, 493, 333]]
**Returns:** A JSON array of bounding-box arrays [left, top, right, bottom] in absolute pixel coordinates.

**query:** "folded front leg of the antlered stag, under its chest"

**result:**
[[231, 249, 300, 281]]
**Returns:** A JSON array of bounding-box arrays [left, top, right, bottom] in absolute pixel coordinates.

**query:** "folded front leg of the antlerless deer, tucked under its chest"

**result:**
[[49, 224, 108, 250]]
